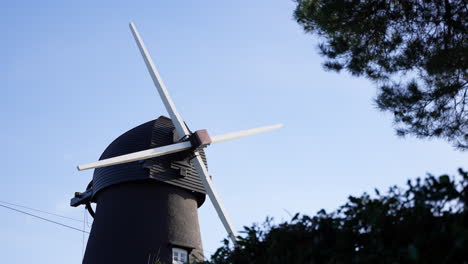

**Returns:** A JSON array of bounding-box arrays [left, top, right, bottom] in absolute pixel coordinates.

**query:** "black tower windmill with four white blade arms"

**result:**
[[71, 23, 282, 263]]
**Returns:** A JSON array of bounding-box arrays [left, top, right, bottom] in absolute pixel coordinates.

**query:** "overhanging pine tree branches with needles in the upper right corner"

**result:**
[[294, 0, 468, 150]]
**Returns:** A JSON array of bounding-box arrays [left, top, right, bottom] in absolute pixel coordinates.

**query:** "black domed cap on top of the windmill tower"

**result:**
[[93, 116, 206, 206]]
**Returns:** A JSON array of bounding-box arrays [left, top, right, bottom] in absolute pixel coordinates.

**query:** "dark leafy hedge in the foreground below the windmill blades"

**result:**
[[205, 169, 468, 264]]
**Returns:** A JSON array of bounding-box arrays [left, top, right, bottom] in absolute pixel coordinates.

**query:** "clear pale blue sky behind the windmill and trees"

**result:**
[[0, 0, 467, 264]]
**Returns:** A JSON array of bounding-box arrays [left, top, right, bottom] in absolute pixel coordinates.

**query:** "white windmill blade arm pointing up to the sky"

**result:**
[[130, 23, 190, 137]]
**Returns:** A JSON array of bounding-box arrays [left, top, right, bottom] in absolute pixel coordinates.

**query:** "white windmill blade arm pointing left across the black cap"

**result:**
[[78, 141, 192, 171]]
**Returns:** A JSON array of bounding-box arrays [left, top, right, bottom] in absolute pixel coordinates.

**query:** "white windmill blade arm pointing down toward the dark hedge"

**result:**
[[192, 152, 237, 246]]
